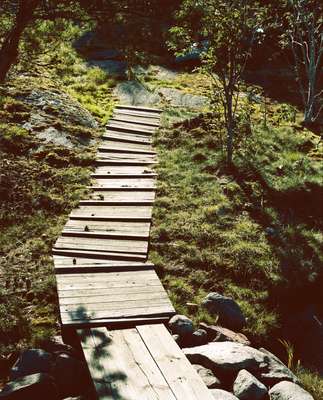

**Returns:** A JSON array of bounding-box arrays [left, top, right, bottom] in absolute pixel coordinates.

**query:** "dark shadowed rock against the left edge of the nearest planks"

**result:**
[[53, 352, 87, 397]]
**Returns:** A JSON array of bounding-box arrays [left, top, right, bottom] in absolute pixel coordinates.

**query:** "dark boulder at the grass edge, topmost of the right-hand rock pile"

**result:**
[[202, 292, 246, 331]]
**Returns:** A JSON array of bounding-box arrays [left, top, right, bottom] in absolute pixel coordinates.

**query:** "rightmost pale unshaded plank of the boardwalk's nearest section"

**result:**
[[137, 325, 213, 400]]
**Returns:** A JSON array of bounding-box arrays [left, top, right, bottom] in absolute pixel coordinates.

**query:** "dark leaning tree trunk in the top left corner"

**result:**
[[0, 0, 40, 83]]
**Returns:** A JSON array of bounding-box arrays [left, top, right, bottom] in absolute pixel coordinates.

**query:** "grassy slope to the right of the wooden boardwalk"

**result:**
[[150, 105, 323, 398]]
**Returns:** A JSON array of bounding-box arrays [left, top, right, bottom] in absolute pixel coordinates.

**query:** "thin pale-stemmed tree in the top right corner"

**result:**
[[283, 0, 323, 125]]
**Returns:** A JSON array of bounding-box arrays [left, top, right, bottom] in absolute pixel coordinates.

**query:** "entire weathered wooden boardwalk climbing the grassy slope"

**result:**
[[53, 106, 212, 400]]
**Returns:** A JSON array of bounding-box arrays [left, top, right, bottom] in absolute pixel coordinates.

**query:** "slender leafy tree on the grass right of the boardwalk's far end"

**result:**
[[171, 0, 263, 165]]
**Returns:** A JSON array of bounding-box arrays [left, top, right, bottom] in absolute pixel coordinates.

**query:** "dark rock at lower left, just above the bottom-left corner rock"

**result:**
[[10, 349, 54, 380]]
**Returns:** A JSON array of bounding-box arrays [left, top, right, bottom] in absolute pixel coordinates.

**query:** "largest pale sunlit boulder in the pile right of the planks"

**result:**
[[183, 342, 293, 383]]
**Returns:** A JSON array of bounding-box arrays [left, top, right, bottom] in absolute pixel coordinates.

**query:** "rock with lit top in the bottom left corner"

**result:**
[[0, 373, 59, 400]]
